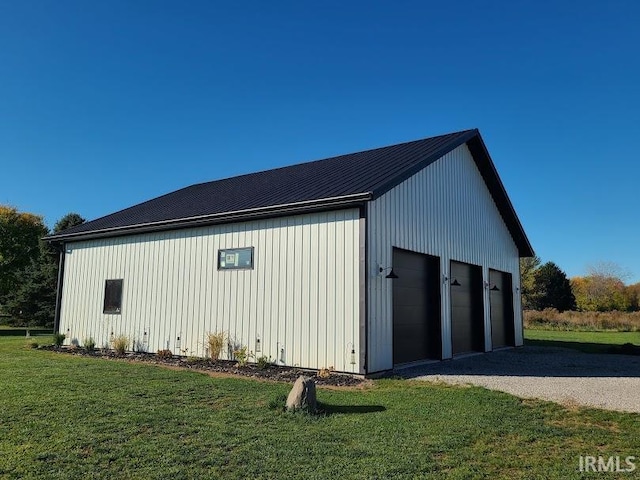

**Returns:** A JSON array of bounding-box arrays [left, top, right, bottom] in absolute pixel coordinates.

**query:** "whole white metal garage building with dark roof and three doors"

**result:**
[[49, 130, 533, 374]]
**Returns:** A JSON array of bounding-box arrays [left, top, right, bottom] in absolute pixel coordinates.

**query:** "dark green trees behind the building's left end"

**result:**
[[0, 205, 85, 327]]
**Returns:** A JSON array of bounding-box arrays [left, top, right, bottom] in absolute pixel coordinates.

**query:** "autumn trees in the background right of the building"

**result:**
[[520, 256, 640, 312]]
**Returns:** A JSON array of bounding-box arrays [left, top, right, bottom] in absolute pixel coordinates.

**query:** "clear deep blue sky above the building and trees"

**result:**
[[0, 0, 640, 282]]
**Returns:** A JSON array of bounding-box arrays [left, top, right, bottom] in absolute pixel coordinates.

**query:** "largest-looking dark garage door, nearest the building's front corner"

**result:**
[[389, 248, 442, 364]]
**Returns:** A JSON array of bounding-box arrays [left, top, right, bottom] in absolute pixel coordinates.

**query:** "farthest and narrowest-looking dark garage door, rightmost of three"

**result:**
[[489, 270, 515, 348]]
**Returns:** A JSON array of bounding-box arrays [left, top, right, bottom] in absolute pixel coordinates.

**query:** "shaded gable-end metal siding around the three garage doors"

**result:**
[[367, 145, 522, 372]]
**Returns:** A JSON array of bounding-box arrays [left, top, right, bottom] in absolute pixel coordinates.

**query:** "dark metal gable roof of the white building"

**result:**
[[47, 130, 533, 256]]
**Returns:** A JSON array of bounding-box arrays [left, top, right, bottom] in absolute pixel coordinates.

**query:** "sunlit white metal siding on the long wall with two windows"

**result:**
[[60, 209, 360, 372]]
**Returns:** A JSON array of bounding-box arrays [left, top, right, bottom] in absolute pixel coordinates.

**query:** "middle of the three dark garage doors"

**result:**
[[449, 262, 484, 355]]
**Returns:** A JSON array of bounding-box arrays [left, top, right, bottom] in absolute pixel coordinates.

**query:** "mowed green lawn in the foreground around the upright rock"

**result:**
[[0, 337, 640, 479]]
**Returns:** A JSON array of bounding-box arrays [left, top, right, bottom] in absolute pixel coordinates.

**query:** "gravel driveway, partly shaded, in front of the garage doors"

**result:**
[[398, 347, 640, 412]]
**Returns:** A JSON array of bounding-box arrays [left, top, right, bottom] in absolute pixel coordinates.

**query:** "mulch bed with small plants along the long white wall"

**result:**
[[38, 345, 366, 387]]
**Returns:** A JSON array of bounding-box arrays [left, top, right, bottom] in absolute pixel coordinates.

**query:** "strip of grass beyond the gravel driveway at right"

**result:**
[[524, 329, 640, 353]]
